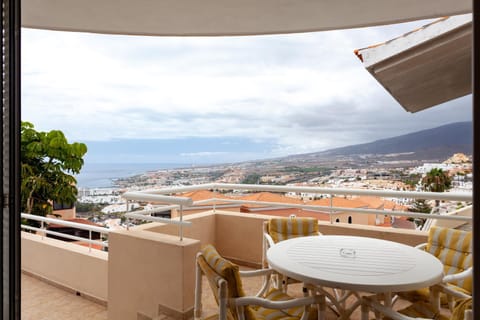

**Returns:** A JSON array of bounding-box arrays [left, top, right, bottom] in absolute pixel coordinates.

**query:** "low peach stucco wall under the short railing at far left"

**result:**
[[21, 232, 108, 304]]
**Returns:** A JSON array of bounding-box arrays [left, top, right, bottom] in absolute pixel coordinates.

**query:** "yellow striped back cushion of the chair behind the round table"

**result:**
[[268, 218, 318, 243]]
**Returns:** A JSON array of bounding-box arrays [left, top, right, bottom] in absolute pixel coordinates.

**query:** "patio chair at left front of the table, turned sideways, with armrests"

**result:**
[[194, 245, 325, 320]]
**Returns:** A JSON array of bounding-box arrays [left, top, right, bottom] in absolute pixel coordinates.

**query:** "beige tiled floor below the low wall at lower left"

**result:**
[[21, 273, 107, 320]]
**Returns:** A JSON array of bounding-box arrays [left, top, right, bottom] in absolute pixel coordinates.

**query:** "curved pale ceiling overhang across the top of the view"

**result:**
[[22, 0, 472, 36]]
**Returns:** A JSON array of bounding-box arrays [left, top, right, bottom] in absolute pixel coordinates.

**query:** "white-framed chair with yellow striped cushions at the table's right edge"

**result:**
[[397, 227, 473, 310]]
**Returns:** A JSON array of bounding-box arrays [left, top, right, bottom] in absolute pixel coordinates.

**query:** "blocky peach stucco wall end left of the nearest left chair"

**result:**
[[108, 228, 200, 320]]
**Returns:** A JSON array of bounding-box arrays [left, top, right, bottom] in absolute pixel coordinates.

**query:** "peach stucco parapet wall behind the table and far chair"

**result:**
[[122, 210, 428, 267]]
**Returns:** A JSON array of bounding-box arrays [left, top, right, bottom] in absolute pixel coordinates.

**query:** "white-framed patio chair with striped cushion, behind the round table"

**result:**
[[262, 216, 322, 292]]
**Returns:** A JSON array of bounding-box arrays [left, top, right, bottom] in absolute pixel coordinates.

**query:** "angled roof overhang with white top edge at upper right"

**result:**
[[356, 14, 472, 112]]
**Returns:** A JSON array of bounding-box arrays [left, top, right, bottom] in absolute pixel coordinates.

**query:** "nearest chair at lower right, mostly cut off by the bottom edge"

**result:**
[[361, 297, 473, 320]]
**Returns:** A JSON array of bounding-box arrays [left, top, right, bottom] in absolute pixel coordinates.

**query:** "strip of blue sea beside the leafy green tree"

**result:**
[[76, 163, 189, 188]]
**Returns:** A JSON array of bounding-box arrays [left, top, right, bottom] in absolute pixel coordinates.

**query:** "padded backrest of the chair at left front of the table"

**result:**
[[197, 245, 252, 319]]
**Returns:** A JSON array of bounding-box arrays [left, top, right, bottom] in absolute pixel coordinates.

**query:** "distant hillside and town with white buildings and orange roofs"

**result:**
[[68, 122, 472, 228]]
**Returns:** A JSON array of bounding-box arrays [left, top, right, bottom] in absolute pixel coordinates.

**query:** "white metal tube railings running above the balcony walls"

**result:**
[[22, 183, 472, 248]]
